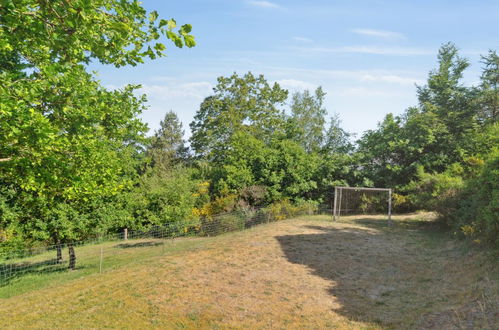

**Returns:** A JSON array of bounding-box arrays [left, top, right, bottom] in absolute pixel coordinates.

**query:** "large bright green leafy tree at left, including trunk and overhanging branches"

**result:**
[[0, 0, 194, 269]]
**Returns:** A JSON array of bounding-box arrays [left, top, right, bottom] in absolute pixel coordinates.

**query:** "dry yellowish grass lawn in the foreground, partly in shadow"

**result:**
[[0, 215, 499, 329]]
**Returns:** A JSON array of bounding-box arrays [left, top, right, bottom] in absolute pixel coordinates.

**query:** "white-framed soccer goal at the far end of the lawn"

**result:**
[[333, 187, 392, 224]]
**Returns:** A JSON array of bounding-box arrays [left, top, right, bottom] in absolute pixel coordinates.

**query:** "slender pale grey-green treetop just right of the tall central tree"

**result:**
[[290, 87, 327, 152]]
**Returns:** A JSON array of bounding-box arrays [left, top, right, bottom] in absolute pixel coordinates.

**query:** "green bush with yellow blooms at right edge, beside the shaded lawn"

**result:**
[[410, 149, 499, 248]]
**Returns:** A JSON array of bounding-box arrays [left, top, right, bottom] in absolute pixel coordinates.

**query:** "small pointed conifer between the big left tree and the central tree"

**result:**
[[148, 111, 188, 170]]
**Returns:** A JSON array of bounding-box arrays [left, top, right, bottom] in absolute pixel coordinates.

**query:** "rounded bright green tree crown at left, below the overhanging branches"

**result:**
[[0, 67, 145, 248]]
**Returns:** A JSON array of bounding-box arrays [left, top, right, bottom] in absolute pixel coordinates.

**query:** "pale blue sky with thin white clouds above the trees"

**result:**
[[91, 0, 499, 136]]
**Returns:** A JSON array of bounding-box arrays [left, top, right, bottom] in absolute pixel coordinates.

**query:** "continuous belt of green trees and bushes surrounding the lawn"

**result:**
[[0, 0, 499, 268]]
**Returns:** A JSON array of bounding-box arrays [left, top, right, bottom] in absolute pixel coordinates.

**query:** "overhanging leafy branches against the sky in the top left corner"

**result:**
[[0, 0, 195, 67]]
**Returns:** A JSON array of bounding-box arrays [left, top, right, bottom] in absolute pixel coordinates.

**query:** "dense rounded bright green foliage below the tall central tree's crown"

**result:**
[[210, 132, 319, 203]]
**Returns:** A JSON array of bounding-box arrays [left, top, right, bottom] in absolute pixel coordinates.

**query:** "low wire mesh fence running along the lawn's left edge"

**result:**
[[0, 205, 331, 289]]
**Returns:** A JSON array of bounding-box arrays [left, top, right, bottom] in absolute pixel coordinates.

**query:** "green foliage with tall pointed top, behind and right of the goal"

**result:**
[[359, 44, 491, 188]]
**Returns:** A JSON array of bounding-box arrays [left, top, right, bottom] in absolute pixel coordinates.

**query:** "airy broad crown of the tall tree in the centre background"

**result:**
[[190, 72, 288, 159]]
